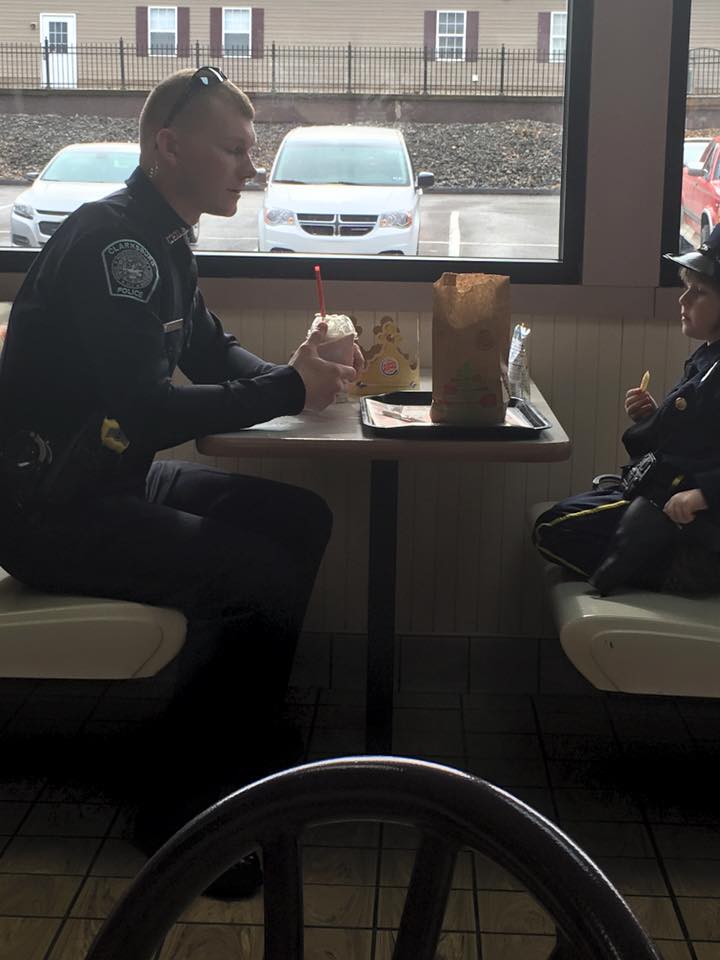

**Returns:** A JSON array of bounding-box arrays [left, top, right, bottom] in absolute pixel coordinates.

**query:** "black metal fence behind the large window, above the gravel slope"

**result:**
[[0, 40, 565, 97]]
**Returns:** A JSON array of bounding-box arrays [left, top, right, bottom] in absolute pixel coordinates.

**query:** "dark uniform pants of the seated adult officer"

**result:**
[[0, 461, 332, 784]]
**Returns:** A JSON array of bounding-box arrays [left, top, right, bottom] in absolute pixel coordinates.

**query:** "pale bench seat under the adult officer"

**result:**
[[0, 569, 187, 680]]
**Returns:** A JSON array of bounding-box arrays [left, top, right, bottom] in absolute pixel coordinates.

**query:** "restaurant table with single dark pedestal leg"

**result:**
[[197, 382, 570, 754]]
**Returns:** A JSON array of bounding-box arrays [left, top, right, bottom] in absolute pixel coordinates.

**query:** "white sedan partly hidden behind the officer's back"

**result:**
[[10, 143, 140, 247]]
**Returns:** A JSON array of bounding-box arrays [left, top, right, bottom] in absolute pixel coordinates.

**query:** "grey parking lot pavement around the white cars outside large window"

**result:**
[[0, 185, 560, 260]]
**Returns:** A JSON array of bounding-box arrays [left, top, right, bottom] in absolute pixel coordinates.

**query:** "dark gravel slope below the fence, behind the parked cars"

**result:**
[[0, 114, 562, 190]]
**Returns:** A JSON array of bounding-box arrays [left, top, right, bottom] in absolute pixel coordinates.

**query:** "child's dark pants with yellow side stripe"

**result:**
[[533, 488, 720, 593]]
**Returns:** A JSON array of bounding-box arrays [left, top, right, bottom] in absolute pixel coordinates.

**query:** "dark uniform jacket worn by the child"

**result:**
[[622, 341, 720, 512]]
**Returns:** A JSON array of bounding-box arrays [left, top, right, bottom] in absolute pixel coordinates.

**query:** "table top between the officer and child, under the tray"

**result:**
[[197, 378, 571, 463]]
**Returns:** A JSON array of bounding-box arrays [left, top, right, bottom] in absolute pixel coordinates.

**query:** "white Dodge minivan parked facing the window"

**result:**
[[258, 126, 435, 256]]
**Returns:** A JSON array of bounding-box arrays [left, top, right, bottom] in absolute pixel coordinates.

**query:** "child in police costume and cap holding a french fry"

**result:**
[[534, 226, 720, 594]]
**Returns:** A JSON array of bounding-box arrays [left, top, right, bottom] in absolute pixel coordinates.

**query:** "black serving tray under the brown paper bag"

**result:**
[[360, 390, 550, 440]]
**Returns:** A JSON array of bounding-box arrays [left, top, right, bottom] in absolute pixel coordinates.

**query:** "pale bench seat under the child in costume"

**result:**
[[531, 503, 720, 697]]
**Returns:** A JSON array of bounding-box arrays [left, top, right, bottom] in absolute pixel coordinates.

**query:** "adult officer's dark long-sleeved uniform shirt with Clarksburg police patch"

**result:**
[[0, 167, 305, 502]]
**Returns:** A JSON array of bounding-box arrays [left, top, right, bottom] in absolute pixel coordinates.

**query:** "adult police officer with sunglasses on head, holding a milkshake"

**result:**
[[0, 67, 362, 895]]
